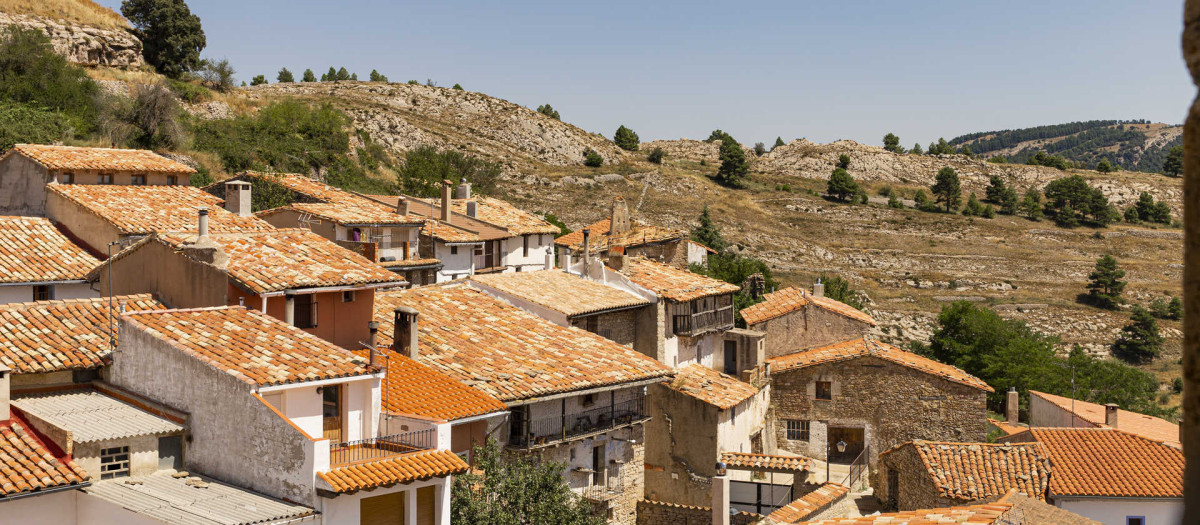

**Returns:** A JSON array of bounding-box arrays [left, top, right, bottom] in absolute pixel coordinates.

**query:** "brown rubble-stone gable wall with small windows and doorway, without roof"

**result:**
[[770, 356, 986, 465]]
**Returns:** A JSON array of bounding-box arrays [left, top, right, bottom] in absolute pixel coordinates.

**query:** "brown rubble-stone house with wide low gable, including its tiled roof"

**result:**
[[764, 339, 991, 466]]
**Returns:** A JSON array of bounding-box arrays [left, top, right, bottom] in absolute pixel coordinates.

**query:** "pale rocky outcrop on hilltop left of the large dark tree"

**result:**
[[0, 13, 145, 68]]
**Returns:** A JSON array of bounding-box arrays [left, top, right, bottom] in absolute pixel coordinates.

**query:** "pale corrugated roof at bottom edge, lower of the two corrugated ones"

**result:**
[[84, 470, 319, 525]]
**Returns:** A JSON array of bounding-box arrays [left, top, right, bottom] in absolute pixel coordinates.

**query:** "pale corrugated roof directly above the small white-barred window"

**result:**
[[12, 390, 184, 442]]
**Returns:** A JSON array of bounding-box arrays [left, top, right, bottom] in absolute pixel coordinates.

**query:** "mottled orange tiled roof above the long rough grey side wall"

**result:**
[[121, 307, 371, 386]]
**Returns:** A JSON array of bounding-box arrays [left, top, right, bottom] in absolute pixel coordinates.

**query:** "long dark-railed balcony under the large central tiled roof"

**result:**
[[509, 394, 648, 448]]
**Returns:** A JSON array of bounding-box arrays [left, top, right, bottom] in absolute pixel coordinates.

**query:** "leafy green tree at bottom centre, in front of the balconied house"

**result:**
[[450, 438, 605, 525]]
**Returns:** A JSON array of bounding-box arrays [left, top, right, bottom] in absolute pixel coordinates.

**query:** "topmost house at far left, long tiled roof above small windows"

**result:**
[[0, 144, 196, 217]]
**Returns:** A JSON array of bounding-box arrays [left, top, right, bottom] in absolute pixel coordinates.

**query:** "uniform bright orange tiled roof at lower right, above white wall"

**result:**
[[1030, 428, 1183, 497]]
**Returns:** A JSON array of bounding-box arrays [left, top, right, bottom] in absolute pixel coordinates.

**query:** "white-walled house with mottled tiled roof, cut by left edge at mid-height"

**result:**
[[0, 217, 100, 304]]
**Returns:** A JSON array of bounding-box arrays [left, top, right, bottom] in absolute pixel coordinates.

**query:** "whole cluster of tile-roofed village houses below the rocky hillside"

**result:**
[[0, 144, 1184, 525]]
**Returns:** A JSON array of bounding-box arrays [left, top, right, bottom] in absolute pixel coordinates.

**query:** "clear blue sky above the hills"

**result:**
[[100, 0, 1193, 146]]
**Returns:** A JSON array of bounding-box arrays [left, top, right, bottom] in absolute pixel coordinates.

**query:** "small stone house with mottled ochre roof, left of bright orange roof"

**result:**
[[872, 441, 1050, 511]]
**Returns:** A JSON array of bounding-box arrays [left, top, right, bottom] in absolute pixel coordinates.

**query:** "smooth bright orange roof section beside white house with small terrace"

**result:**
[[354, 349, 504, 421]]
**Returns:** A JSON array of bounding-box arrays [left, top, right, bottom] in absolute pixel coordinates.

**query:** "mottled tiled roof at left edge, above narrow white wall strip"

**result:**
[[0, 217, 100, 283]]
